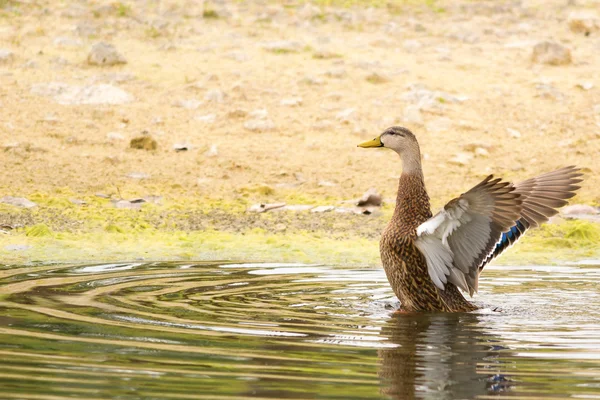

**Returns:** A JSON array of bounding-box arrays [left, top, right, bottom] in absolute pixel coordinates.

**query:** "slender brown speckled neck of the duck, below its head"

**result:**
[[392, 154, 431, 235]]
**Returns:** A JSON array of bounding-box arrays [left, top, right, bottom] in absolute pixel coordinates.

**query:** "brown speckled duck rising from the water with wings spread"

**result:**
[[358, 126, 583, 313]]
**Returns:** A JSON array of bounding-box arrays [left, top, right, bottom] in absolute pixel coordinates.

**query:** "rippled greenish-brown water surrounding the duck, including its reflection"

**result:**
[[0, 263, 600, 400]]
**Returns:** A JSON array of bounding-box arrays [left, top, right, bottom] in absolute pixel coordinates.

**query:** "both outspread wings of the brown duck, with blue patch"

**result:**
[[415, 167, 581, 295]]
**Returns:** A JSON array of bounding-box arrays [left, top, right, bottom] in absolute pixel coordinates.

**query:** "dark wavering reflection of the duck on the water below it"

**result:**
[[379, 313, 511, 399]]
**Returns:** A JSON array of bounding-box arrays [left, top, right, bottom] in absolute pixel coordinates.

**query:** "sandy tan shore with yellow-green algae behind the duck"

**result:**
[[0, 0, 600, 264]]
